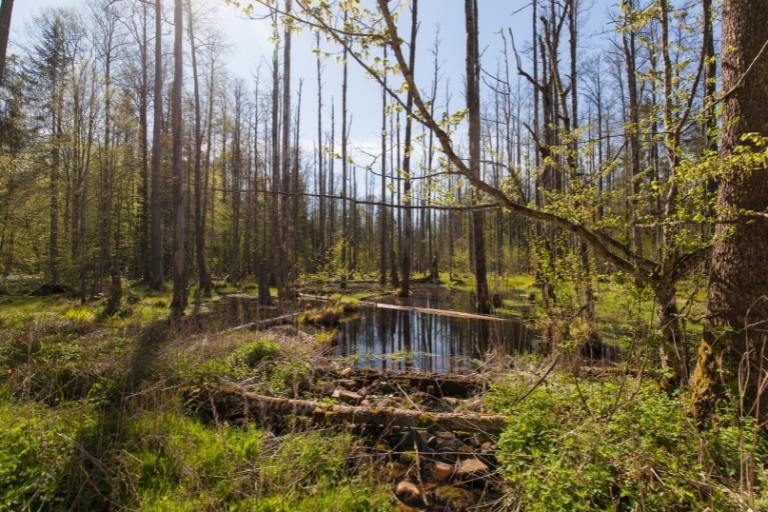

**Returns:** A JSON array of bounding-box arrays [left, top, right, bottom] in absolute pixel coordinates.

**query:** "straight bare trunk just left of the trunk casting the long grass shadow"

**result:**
[[150, 0, 163, 290]]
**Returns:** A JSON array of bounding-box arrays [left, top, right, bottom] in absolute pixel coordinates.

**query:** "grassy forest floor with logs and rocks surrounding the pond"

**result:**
[[0, 276, 768, 511]]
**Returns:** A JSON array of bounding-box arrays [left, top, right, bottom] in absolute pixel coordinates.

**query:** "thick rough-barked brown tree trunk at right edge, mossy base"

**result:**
[[692, 0, 768, 419]]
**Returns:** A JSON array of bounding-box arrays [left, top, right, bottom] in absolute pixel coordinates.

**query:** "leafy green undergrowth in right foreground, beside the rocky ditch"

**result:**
[[491, 377, 765, 512]]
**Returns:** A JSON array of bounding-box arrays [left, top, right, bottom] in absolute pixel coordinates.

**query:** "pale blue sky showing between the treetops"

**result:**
[[10, 0, 607, 173]]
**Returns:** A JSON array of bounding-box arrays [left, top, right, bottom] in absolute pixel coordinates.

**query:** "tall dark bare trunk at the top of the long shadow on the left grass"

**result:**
[[171, 0, 187, 318]]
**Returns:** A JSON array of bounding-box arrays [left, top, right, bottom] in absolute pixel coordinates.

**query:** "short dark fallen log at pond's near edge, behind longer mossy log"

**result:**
[[329, 368, 488, 397]]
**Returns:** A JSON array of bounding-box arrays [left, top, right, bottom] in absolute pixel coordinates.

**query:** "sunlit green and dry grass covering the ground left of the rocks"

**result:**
[[0, 287, 390, 512]]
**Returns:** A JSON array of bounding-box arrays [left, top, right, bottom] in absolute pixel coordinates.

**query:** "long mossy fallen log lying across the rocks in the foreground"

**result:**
[[201, 387, 507, 434]]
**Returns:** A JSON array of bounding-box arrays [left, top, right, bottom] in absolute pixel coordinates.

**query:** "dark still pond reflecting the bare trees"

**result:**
[[334, 287, 539, 373]]
